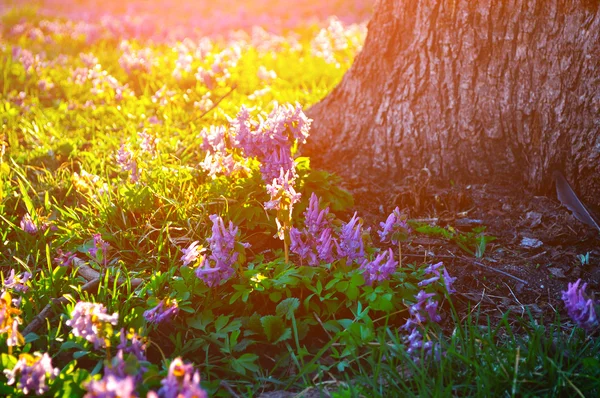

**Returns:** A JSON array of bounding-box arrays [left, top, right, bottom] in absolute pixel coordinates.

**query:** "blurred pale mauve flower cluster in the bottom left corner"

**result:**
[[4, 352, 59, 395]]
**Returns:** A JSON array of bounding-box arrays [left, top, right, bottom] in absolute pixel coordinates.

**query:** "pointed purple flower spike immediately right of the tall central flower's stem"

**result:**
[[290, 192, 336, 266]]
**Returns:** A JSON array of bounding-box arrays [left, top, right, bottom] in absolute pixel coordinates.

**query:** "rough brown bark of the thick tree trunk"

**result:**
[[305, 0, 600, 206]]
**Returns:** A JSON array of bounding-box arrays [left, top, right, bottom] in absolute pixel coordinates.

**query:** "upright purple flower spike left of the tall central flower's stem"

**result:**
[[196, 214, 250, 287]]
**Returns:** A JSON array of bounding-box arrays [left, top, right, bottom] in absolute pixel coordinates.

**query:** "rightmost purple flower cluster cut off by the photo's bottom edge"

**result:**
[[158, 358, 208, 398]]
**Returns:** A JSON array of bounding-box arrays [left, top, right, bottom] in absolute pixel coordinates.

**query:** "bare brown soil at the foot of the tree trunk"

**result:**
[[350, 174, 600, 322]]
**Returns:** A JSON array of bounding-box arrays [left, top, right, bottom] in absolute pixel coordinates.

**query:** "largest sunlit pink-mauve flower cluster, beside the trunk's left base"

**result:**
[[231, 104, 312, 183]]
